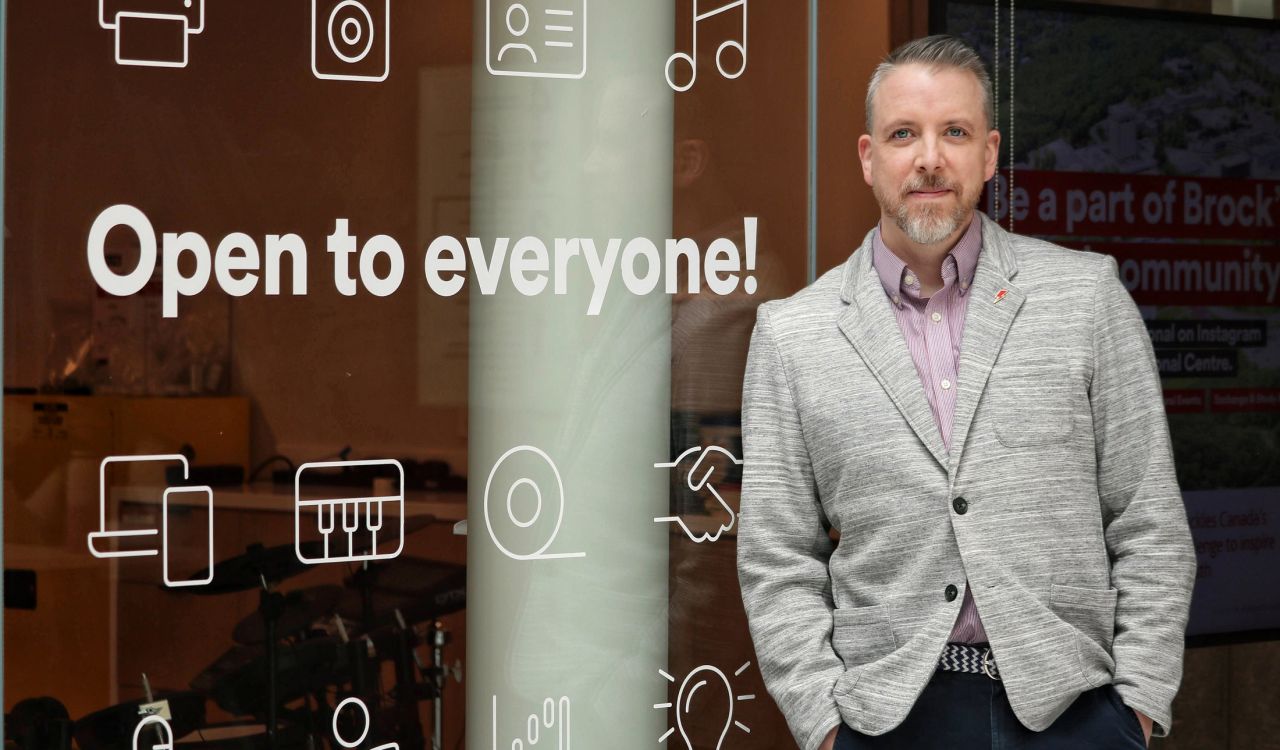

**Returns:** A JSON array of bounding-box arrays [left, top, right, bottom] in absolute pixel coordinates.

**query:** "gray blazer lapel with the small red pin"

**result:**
[[947, 211, 1025, 474]]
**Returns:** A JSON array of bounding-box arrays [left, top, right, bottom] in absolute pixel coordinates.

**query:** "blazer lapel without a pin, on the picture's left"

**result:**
[[838, 233, 947, 468]]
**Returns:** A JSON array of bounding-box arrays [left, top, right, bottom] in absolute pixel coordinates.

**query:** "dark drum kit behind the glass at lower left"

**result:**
[[72, 516, 466, 750]]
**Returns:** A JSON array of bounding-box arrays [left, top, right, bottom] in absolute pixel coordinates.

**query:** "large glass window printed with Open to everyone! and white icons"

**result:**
[[4, 0, 808, 750]]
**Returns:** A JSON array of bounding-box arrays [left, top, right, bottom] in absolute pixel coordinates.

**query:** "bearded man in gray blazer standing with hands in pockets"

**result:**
[[739, 36, 1196, 750]]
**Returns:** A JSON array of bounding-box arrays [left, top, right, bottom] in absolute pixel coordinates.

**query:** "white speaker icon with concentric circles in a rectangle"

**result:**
[[311, 0, 392, 81]]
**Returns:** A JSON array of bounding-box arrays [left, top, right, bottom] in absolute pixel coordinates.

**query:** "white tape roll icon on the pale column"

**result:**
[[484, 445, 586, 559]]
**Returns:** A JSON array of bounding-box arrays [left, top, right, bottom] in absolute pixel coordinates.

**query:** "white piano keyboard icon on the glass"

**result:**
[[293, 458, 404, 564]]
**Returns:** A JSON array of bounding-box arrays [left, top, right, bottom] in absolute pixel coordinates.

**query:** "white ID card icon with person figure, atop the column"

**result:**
[[484, 0, 588, 78]]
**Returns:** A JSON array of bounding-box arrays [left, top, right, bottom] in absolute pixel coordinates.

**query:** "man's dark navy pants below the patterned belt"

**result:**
[[835, 669, 1147, 750]]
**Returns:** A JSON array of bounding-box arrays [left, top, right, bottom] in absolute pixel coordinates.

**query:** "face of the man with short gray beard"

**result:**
[[858, 64, 1000, 244]]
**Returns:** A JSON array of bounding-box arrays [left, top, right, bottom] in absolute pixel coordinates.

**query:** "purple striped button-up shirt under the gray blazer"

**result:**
[[872, 216, 987, 644]]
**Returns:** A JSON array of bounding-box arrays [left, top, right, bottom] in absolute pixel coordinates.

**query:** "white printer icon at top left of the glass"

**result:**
[[97, 0, 205, 68]]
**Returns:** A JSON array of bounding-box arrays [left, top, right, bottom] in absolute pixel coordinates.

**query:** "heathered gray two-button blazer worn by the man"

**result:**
[[737, 214, 1196, 750]]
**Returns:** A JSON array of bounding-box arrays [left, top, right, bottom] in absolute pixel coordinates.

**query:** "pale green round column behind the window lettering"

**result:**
[[466, 0, 673, 750]]
